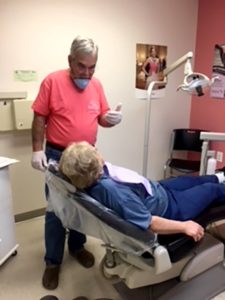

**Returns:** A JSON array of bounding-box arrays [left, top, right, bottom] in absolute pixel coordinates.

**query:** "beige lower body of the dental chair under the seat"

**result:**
[[101, 233, 224, 290]]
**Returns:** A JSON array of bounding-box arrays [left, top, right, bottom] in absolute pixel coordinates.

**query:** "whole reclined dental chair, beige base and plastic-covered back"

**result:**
[[46, 164, 225, 300]]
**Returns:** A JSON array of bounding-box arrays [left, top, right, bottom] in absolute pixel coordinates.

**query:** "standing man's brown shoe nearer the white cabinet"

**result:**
[[42, 265, 60, 290]]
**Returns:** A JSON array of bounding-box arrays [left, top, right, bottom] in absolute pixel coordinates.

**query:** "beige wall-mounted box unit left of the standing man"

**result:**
[[0, 92, 33, 131]]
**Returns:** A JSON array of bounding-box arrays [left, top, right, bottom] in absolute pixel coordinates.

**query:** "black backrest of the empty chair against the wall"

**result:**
[[172, 128, 205, 152]]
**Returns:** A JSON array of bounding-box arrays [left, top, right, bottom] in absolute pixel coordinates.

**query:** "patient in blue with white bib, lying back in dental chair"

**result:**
[[59, 142, 225, 241]]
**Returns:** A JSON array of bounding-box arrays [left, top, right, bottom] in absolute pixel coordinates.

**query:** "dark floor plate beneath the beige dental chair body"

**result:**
[[113, 262, 225, 300]]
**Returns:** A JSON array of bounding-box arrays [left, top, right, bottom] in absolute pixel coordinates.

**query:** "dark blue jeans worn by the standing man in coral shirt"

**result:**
[[44, 146, 86, 265]]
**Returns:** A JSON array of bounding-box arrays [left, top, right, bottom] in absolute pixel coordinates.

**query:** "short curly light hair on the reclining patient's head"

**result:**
[[59, 142, 102, 189]]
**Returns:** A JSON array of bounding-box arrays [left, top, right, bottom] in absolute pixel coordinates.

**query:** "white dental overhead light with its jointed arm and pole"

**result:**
[[143, 51, 219, 177]]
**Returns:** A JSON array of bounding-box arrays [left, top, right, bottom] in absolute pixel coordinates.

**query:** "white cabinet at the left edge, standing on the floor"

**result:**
[[0, 157, 18, 265]]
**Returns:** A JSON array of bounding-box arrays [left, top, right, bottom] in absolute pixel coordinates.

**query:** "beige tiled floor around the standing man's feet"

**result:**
[[0, 217, 225, 300]]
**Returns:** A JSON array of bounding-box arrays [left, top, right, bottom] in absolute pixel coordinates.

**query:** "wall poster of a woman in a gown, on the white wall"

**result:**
[[135, 44, 167, 98]]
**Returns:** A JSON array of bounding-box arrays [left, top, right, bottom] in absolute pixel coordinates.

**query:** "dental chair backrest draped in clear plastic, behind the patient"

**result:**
[[46, 165, 157, 255]]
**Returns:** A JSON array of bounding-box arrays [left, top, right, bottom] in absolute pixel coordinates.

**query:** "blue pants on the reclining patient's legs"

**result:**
[[160, 175, 225, 221]]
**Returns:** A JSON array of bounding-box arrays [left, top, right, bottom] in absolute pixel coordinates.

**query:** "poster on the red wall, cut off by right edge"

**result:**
[[210, 44, 225, 98]]
